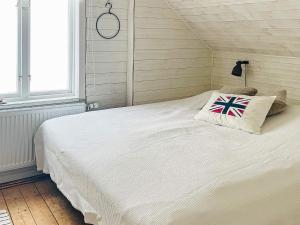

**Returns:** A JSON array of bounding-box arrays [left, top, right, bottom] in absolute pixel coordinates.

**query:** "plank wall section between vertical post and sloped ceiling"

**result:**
[[134, 0, 212, 104]]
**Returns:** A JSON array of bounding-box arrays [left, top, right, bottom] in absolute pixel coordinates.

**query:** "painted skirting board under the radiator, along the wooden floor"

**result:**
[[0, 166, 42, 184]]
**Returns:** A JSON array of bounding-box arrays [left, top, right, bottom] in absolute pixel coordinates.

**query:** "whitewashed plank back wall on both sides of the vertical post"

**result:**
[[86, 0, 212, 108]]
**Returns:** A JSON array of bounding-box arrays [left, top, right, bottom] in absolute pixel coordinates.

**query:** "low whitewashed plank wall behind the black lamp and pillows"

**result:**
[[212, 51, 300, 102]]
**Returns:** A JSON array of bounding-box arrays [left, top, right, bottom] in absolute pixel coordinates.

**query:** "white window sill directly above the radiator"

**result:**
[[0, 97, 85, 111]]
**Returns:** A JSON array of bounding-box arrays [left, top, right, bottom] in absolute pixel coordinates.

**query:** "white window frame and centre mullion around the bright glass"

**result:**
[[1, 0, 85, 103]]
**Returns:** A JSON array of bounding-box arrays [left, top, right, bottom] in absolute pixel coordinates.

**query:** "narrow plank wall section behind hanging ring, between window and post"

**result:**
[[86, 0, 128, 108]]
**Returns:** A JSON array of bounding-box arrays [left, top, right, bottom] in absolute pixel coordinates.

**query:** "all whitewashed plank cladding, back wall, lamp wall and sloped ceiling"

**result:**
[[87, 0, 300, 108]]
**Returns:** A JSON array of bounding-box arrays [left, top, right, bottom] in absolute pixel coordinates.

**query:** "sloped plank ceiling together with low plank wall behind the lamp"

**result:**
[[167, 0, 300, 100]]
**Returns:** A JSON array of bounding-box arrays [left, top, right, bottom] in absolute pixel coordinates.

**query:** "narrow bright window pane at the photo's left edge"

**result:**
[[0, 0, 18, 95]]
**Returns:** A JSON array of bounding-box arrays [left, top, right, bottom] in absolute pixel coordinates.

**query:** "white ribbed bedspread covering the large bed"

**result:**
[[35, 93, 300, 225]]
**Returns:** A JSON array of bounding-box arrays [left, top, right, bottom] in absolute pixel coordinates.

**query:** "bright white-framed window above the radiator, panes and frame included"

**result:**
[[0, 0, 78, 101]]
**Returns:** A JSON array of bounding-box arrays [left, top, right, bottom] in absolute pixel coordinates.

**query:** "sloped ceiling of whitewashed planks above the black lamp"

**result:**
[[167, 0, 300, 56]]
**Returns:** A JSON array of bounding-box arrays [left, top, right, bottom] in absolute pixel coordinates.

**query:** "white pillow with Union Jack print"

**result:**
[[195, 92, 276, 134]]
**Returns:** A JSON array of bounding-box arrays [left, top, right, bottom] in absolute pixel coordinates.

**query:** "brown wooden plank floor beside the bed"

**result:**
[[0, 179, 89, 225]]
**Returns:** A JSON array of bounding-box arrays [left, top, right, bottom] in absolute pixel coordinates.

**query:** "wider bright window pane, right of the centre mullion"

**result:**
[[30, 0, 70, 92]]
